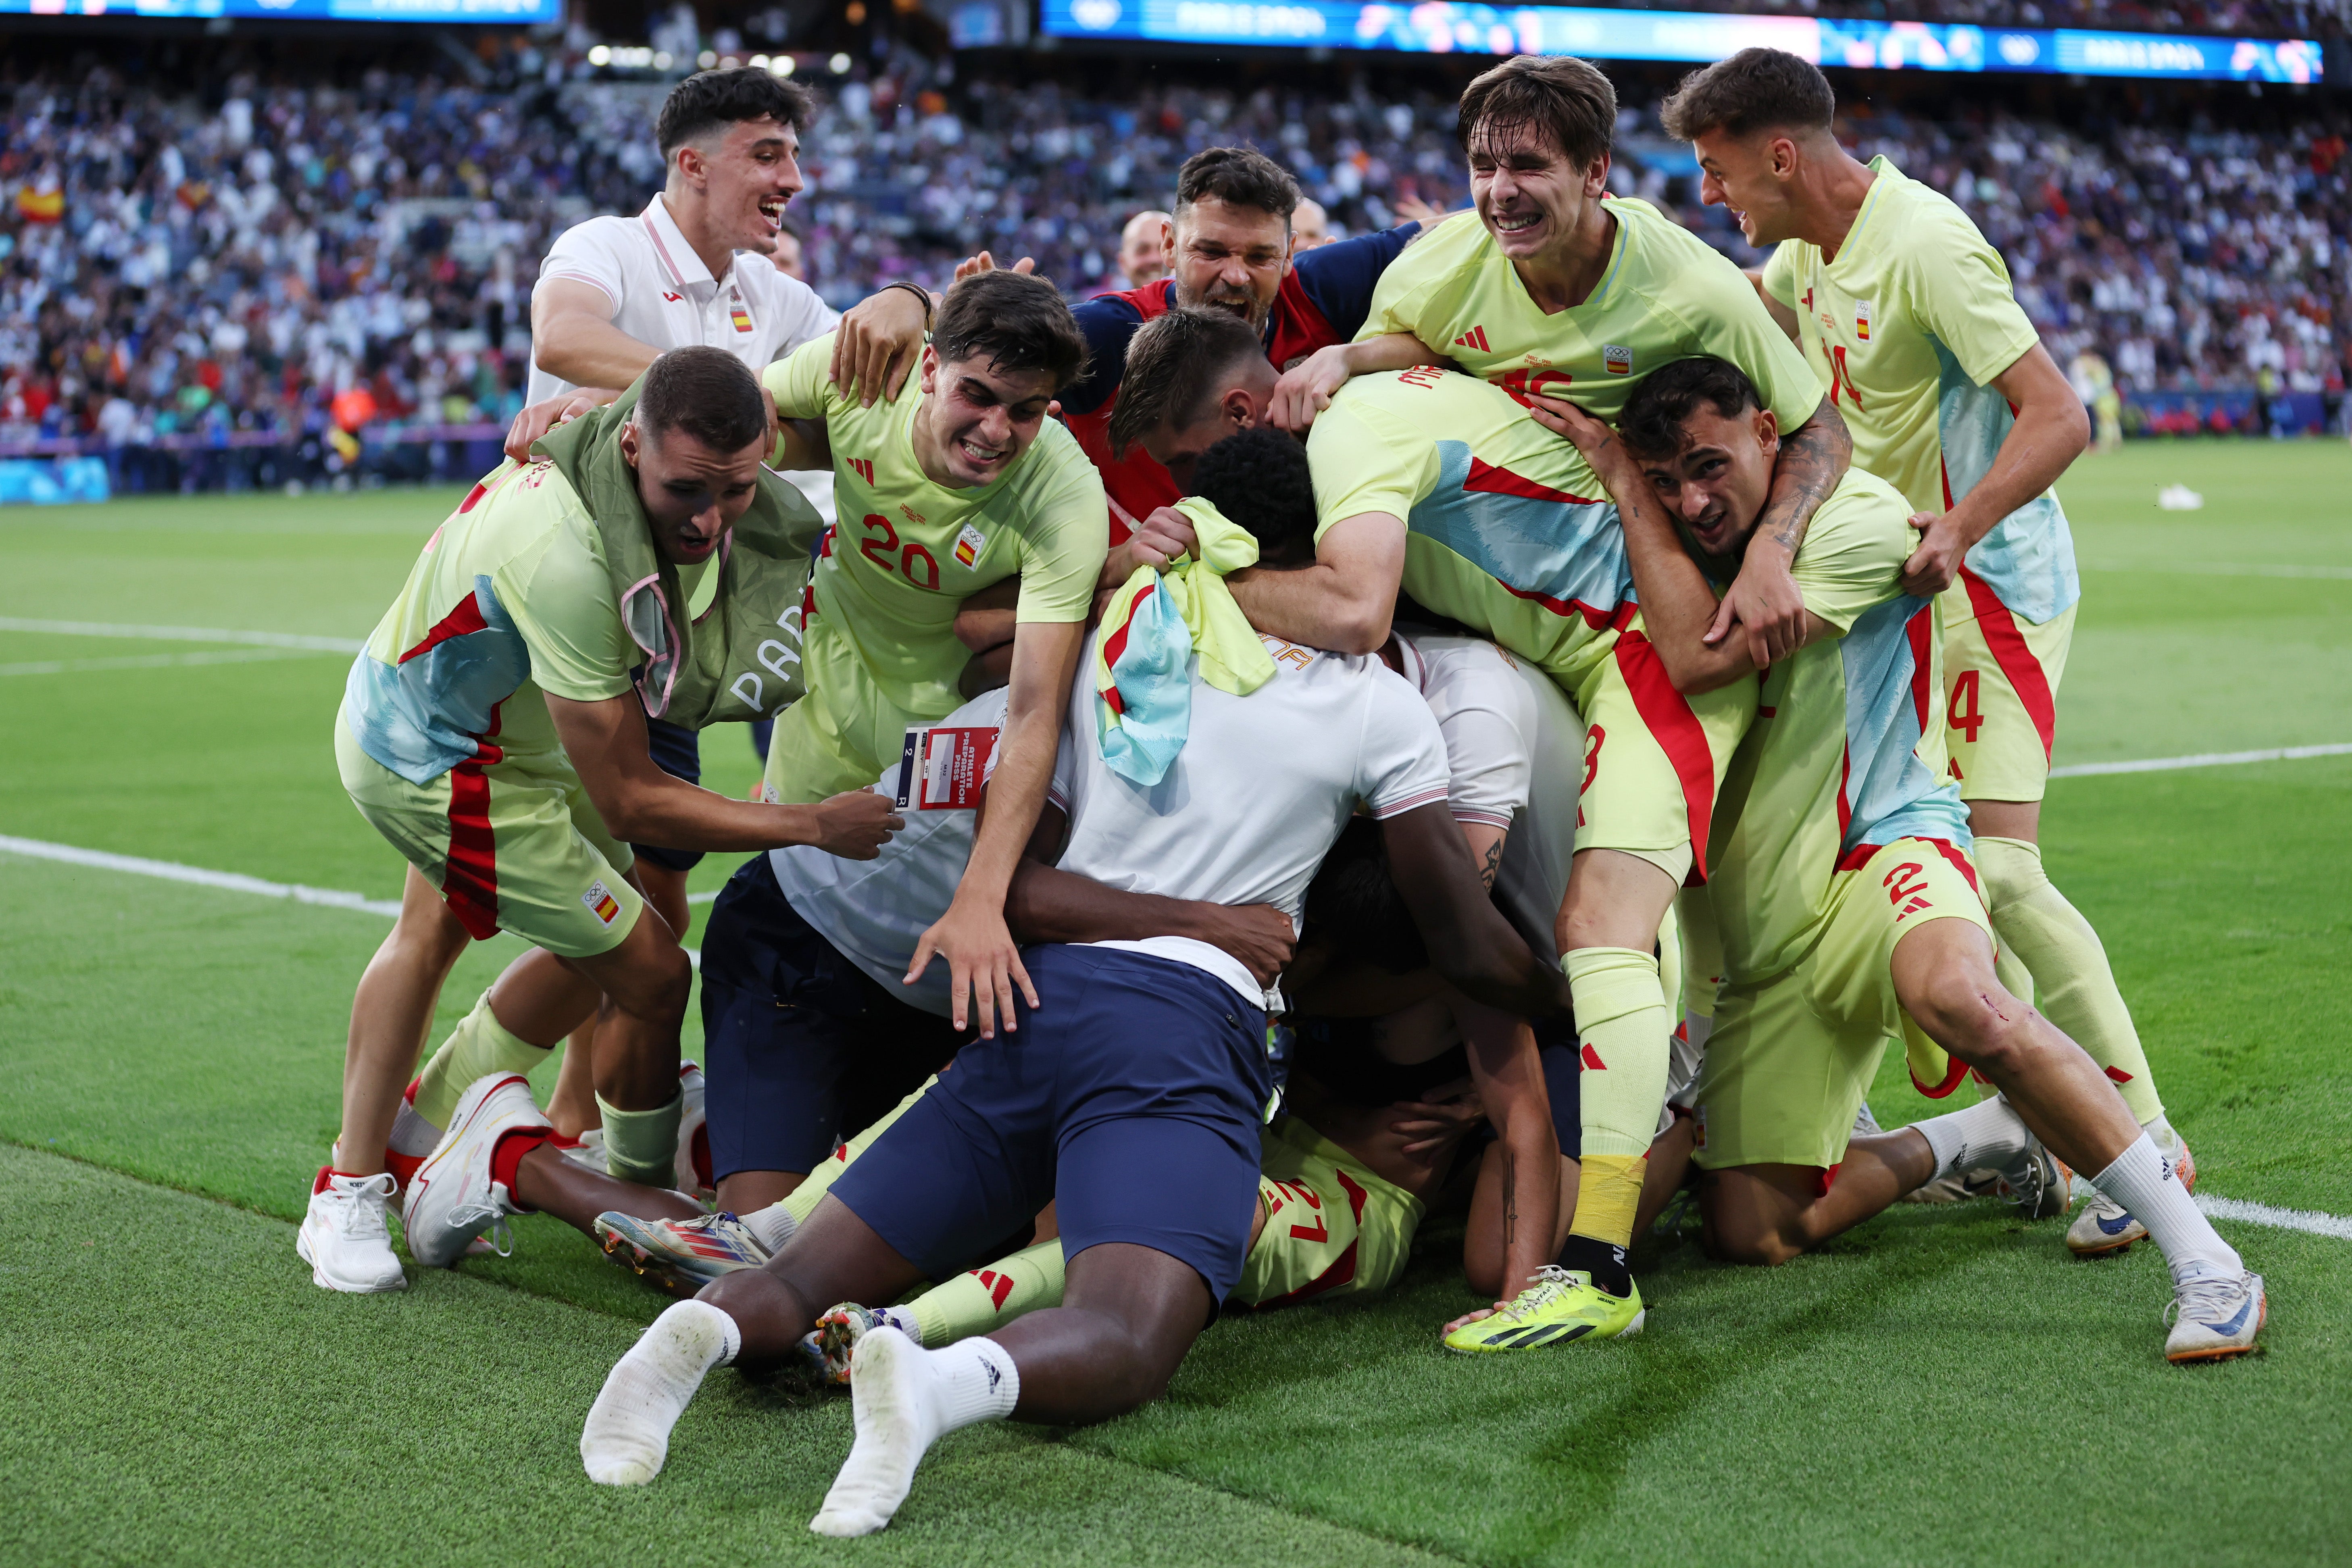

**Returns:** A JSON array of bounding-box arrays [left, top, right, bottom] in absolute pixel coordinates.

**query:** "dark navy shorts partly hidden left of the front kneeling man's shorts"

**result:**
[[701, 856, 959, 1175]]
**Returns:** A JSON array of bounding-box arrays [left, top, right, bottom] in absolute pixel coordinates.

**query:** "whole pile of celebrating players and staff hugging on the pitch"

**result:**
[[299, 49, 2265, 1535]]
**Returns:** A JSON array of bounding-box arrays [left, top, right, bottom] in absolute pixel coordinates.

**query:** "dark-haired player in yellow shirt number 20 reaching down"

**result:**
[[765, 271, 1108, 1037]]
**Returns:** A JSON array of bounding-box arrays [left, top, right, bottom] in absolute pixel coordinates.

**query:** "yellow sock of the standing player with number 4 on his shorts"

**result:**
[[1976, 837, 2164, 1126]]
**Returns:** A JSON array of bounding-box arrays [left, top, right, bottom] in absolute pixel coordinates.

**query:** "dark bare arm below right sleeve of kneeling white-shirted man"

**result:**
[[1381, 804, 1569, 1018]]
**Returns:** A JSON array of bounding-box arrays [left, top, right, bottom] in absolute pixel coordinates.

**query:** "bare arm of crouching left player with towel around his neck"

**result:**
[[548, 691, 906, 860]]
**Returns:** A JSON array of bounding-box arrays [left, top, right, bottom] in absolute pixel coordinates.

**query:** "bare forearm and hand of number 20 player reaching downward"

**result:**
[[906, 621, 1087, 1039]]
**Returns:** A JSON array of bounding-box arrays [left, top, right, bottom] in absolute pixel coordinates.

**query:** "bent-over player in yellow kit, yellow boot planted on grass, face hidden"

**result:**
[[1115, 310, 1754, 1349]]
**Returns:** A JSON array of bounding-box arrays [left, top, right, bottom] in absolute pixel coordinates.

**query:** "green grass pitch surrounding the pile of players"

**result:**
[[0, 442, 2352, 1563]]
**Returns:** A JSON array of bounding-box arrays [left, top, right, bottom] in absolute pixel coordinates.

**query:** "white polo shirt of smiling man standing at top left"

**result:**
[[529, 193, 840, 402]]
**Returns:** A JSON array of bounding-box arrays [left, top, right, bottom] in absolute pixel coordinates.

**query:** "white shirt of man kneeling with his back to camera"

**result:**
[[1051, 637, 1446, 1006]]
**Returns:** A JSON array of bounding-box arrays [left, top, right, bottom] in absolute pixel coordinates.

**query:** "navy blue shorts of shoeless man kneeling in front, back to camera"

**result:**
[[833, 945, 1273, 1302]]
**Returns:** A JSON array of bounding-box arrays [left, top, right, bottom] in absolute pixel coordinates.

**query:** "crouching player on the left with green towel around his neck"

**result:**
[[296, 348, 898, 1288]]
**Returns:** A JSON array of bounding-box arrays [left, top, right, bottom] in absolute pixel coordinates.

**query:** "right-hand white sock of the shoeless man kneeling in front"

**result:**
[[809, 1328, 1021, 1535]]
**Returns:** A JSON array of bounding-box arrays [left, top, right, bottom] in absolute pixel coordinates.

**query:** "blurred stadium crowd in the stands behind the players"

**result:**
[[0, 52, 2352, 475]]
